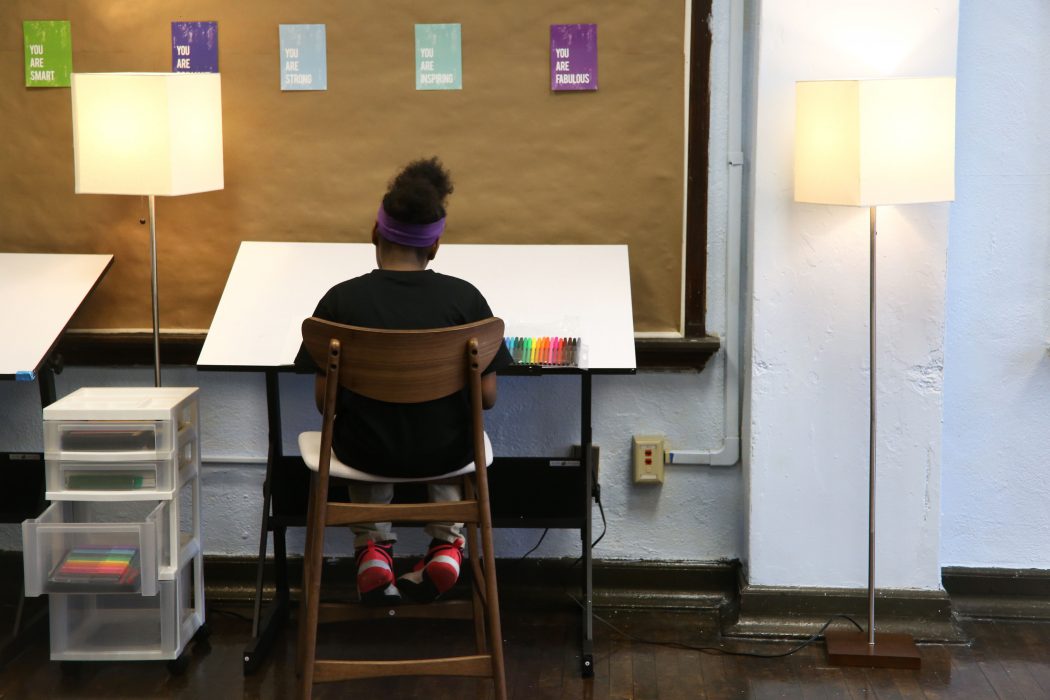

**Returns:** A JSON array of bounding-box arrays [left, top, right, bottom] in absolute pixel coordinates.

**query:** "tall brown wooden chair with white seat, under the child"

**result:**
[[296, 318, 507, 700]]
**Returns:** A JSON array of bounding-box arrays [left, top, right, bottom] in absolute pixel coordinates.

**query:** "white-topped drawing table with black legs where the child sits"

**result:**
[[197, 241, 635, 676]]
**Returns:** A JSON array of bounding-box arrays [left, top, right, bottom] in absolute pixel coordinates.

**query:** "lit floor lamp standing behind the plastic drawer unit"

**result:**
[[71, 72, 223, 386]]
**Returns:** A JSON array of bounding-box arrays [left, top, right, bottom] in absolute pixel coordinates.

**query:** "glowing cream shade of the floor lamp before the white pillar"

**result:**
[[795, 78, 956, 207]]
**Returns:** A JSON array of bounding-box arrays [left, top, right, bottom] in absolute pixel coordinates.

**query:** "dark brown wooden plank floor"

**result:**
[[0, 602, 1050, 700]]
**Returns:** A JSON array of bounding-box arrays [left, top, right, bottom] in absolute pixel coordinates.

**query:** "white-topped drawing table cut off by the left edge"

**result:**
[[0, 248, 113, 666]]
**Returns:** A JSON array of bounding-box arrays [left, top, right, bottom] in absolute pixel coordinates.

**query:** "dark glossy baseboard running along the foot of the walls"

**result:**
[[0, 552, 1050, 642]]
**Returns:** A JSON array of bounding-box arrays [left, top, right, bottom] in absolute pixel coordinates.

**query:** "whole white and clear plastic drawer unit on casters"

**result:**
[[22, 387, 207, 669]]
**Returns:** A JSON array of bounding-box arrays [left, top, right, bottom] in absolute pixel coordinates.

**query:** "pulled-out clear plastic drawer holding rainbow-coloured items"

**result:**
[[22, 502, 163, 596]]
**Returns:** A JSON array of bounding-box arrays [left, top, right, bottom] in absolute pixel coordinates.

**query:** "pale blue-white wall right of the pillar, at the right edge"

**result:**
[[941, 0, 1050, 569]]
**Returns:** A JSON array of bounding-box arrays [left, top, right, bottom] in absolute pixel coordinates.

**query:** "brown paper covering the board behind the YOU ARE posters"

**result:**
[[0, 0, 685, 331]]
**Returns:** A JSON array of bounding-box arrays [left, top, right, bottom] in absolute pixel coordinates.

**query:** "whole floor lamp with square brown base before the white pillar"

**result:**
[[795, 78, 956, 669]]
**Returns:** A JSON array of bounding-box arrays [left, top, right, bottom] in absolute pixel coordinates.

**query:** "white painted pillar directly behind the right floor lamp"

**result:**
[[746, 0, 958, 590]]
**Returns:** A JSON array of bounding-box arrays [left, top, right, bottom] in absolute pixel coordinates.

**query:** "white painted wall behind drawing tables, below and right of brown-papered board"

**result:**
[[0, 0, 744, 561]]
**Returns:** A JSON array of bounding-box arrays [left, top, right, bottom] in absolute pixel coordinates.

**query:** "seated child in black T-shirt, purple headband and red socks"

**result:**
[[296, 157, 511, 604]]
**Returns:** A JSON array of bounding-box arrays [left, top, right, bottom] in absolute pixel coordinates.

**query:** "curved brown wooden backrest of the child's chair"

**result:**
[[302, 317, 503, 403]]
